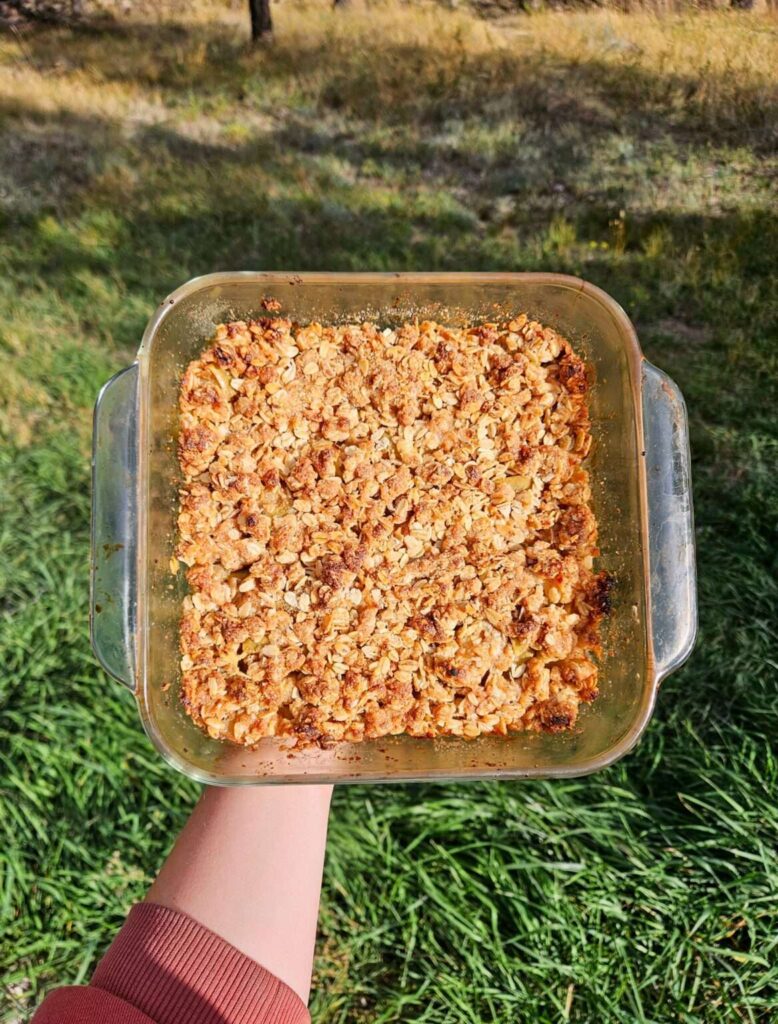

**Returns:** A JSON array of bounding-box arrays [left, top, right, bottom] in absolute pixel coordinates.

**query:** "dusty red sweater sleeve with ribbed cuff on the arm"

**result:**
[[31, 903, 310, 1024]]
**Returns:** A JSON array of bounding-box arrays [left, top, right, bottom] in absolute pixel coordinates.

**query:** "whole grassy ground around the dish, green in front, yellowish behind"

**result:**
[[0, 5, 778, 1024]]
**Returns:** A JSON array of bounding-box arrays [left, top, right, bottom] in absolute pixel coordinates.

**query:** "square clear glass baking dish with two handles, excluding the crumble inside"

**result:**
[[91, 272, 697, 785]]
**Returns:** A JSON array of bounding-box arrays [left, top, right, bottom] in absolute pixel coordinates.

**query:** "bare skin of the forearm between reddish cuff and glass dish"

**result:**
[[146, 786, 332, 1000]]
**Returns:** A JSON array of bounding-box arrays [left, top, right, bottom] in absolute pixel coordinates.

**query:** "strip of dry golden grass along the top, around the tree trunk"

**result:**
[[0, 0, 778, 132]]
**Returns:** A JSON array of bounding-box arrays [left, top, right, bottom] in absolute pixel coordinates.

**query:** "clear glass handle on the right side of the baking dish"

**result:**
[[642, 361, 697, 681]]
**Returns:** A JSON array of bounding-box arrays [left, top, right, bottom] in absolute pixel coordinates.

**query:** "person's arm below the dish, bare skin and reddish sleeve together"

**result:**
[[35, 786, 332, 1024]]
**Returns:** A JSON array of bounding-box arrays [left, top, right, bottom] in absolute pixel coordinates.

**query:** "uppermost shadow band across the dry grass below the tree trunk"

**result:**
[[6, 15, 778, 152]]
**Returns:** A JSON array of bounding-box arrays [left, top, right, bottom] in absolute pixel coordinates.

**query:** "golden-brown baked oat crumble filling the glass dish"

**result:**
[[176, 316, 608, 745]]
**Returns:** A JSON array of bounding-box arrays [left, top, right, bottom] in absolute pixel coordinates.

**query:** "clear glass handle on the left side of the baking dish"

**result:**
[[89, 362, 138, 689]]
